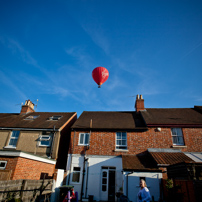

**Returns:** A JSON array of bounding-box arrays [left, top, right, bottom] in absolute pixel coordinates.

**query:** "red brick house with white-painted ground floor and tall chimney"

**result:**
[[66, 95, 202, 201]]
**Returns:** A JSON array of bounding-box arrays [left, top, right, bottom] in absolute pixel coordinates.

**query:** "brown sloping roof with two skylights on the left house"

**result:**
[[0, 112, 76, 129]]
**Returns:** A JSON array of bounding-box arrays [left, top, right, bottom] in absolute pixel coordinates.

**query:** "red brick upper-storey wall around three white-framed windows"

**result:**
[[70, 128, 202, 155]]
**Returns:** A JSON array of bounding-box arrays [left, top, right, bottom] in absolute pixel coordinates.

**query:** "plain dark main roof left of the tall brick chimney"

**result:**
[[72, 111, 146, 130]]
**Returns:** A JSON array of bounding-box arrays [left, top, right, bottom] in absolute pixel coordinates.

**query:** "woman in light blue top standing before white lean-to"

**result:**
[[137, 179, 151, 202]]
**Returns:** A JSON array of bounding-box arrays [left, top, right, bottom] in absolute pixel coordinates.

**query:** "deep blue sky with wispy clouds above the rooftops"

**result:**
[[0, 0, 202, 115]]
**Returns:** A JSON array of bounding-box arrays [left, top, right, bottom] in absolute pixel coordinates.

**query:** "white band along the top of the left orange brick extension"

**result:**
[[0, 151, 56, 165]]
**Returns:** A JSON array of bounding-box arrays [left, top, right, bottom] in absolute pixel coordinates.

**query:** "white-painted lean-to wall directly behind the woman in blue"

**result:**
[[123, 172, 162, 202]]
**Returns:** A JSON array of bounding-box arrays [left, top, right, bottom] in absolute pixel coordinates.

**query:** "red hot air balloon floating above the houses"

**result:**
[[92, 67, 109, 88]]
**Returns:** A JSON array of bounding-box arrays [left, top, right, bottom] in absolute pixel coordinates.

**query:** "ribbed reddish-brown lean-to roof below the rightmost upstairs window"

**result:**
[[149, 152, 193, 165]]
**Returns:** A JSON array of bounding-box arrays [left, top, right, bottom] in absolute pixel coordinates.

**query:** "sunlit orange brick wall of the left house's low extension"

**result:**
[[0, 157, 55, 180]]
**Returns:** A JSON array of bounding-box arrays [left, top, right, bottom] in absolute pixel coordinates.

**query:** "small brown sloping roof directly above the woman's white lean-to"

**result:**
[[122, 155, 159, 171]]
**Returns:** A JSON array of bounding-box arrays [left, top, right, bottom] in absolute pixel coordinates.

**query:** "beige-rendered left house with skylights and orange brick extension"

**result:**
[[0, 100, 77, 180]]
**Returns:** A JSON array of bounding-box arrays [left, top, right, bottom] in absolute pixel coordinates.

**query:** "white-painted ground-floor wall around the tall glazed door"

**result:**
[[68, 155, 123, 201]]
